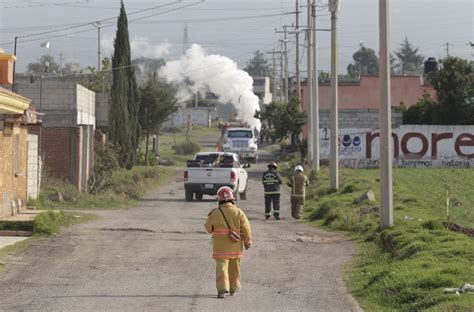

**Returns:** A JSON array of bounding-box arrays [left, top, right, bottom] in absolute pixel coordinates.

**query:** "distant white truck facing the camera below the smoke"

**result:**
[[222, 128, 258, 163]]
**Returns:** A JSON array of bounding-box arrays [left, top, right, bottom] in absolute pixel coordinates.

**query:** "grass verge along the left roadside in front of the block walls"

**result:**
[[29, 166, 174, 209]]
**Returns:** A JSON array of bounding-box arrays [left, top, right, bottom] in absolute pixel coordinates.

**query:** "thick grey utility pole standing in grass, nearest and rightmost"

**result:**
[[379, 0, 393, 229]]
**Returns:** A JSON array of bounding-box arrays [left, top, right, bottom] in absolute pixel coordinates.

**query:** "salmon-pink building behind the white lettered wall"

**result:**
[[301, 76, 436, 137]]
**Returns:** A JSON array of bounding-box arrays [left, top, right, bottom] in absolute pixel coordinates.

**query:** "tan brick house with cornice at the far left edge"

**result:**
[[0, 50, 38, 219]]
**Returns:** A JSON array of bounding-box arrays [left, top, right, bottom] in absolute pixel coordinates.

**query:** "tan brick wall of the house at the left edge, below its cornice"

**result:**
[[0, 124, 28, 219]]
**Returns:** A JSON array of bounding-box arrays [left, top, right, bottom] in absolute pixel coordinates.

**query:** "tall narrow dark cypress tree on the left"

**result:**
[[109, 1, 140, 169]]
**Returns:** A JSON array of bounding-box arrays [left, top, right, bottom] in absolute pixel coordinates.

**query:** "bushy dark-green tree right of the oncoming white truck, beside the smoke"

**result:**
[[255, 97, 306, 145]]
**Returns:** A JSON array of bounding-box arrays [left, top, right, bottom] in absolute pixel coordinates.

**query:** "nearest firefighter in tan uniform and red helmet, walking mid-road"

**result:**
[[204, 186, 252, 298]]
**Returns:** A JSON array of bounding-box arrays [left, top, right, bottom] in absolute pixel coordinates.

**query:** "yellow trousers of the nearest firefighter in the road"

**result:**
[[216, 259, 240, 292]]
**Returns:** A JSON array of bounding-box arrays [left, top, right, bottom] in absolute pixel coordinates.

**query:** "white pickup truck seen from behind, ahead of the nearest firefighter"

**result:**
[[184, 152, 250, 201]]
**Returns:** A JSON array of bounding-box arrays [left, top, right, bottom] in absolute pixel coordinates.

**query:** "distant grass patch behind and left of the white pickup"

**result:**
[[160, 126, 220, 167]]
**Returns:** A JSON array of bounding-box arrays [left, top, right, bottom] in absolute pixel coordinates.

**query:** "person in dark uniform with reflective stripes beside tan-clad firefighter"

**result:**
[[262, 161, 283, 220]]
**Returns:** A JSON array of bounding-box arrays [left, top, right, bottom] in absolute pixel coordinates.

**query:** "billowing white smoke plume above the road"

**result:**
[[160, 44, 260, 129]]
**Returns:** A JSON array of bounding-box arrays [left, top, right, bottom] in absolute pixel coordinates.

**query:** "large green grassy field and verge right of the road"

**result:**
[[305, 167, 474, 311]]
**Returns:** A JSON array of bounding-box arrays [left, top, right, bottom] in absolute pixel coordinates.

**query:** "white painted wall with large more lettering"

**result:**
[[320, 125, 474, 168]]
